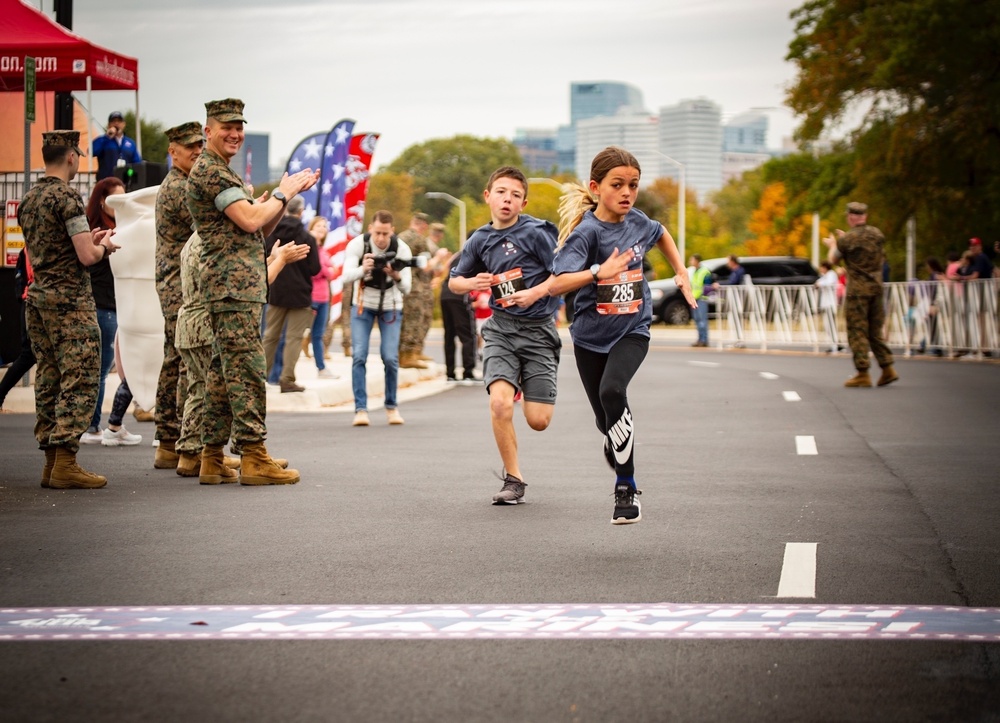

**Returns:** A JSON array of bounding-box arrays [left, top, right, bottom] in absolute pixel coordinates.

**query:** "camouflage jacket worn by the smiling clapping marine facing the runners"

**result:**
[[187, 148, 267, 304]]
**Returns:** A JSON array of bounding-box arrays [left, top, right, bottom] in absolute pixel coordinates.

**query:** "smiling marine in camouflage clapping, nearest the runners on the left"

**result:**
[[187, 98, 319, 485]]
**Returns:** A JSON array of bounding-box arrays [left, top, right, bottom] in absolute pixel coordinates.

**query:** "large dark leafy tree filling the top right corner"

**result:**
[[787, 0, 1000, 264]]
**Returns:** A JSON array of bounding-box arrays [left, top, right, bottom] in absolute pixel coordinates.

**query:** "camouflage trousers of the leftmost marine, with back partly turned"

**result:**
[[25, 304, 101, 452]]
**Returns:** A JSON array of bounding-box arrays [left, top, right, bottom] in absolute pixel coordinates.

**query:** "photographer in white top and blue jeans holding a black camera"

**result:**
[[343, 211, 414, 427]]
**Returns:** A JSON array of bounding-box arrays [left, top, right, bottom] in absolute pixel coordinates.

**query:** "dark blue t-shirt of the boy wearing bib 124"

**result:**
[[451, 213, 559, 319]]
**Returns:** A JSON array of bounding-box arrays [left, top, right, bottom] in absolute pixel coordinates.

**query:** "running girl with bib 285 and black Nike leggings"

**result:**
[[549, 146, 696, 525]]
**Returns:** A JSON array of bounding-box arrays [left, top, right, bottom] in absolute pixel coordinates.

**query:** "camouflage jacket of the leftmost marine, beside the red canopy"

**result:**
[[17, 176, 96, 311]]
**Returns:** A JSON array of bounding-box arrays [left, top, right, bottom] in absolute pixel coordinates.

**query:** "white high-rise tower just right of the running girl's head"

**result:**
[[658, 98, 722, 201]]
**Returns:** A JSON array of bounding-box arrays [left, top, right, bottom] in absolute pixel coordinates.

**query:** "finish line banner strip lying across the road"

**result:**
[[0, 603, 1000, 642]]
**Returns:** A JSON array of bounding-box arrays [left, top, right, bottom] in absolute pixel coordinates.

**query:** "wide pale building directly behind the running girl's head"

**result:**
[[575, 107, 661, 187]]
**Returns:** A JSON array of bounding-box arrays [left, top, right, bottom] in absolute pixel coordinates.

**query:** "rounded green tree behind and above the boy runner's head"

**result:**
[[385, 135, 521, 218]]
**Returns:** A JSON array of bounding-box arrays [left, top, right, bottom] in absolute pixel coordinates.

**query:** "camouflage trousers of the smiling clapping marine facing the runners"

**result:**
[[202, 299, 267, 447]]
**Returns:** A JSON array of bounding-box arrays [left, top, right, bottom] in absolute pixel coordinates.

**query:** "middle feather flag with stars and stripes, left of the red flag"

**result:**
[[317, 118, 354, 319]]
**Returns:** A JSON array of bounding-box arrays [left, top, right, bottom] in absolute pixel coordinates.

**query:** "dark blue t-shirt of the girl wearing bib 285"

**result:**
[[554, 208, 664, 354]]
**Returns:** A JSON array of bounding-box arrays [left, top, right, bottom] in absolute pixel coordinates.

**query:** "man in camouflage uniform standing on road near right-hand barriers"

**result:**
[[826, 202, 899, 387]]
